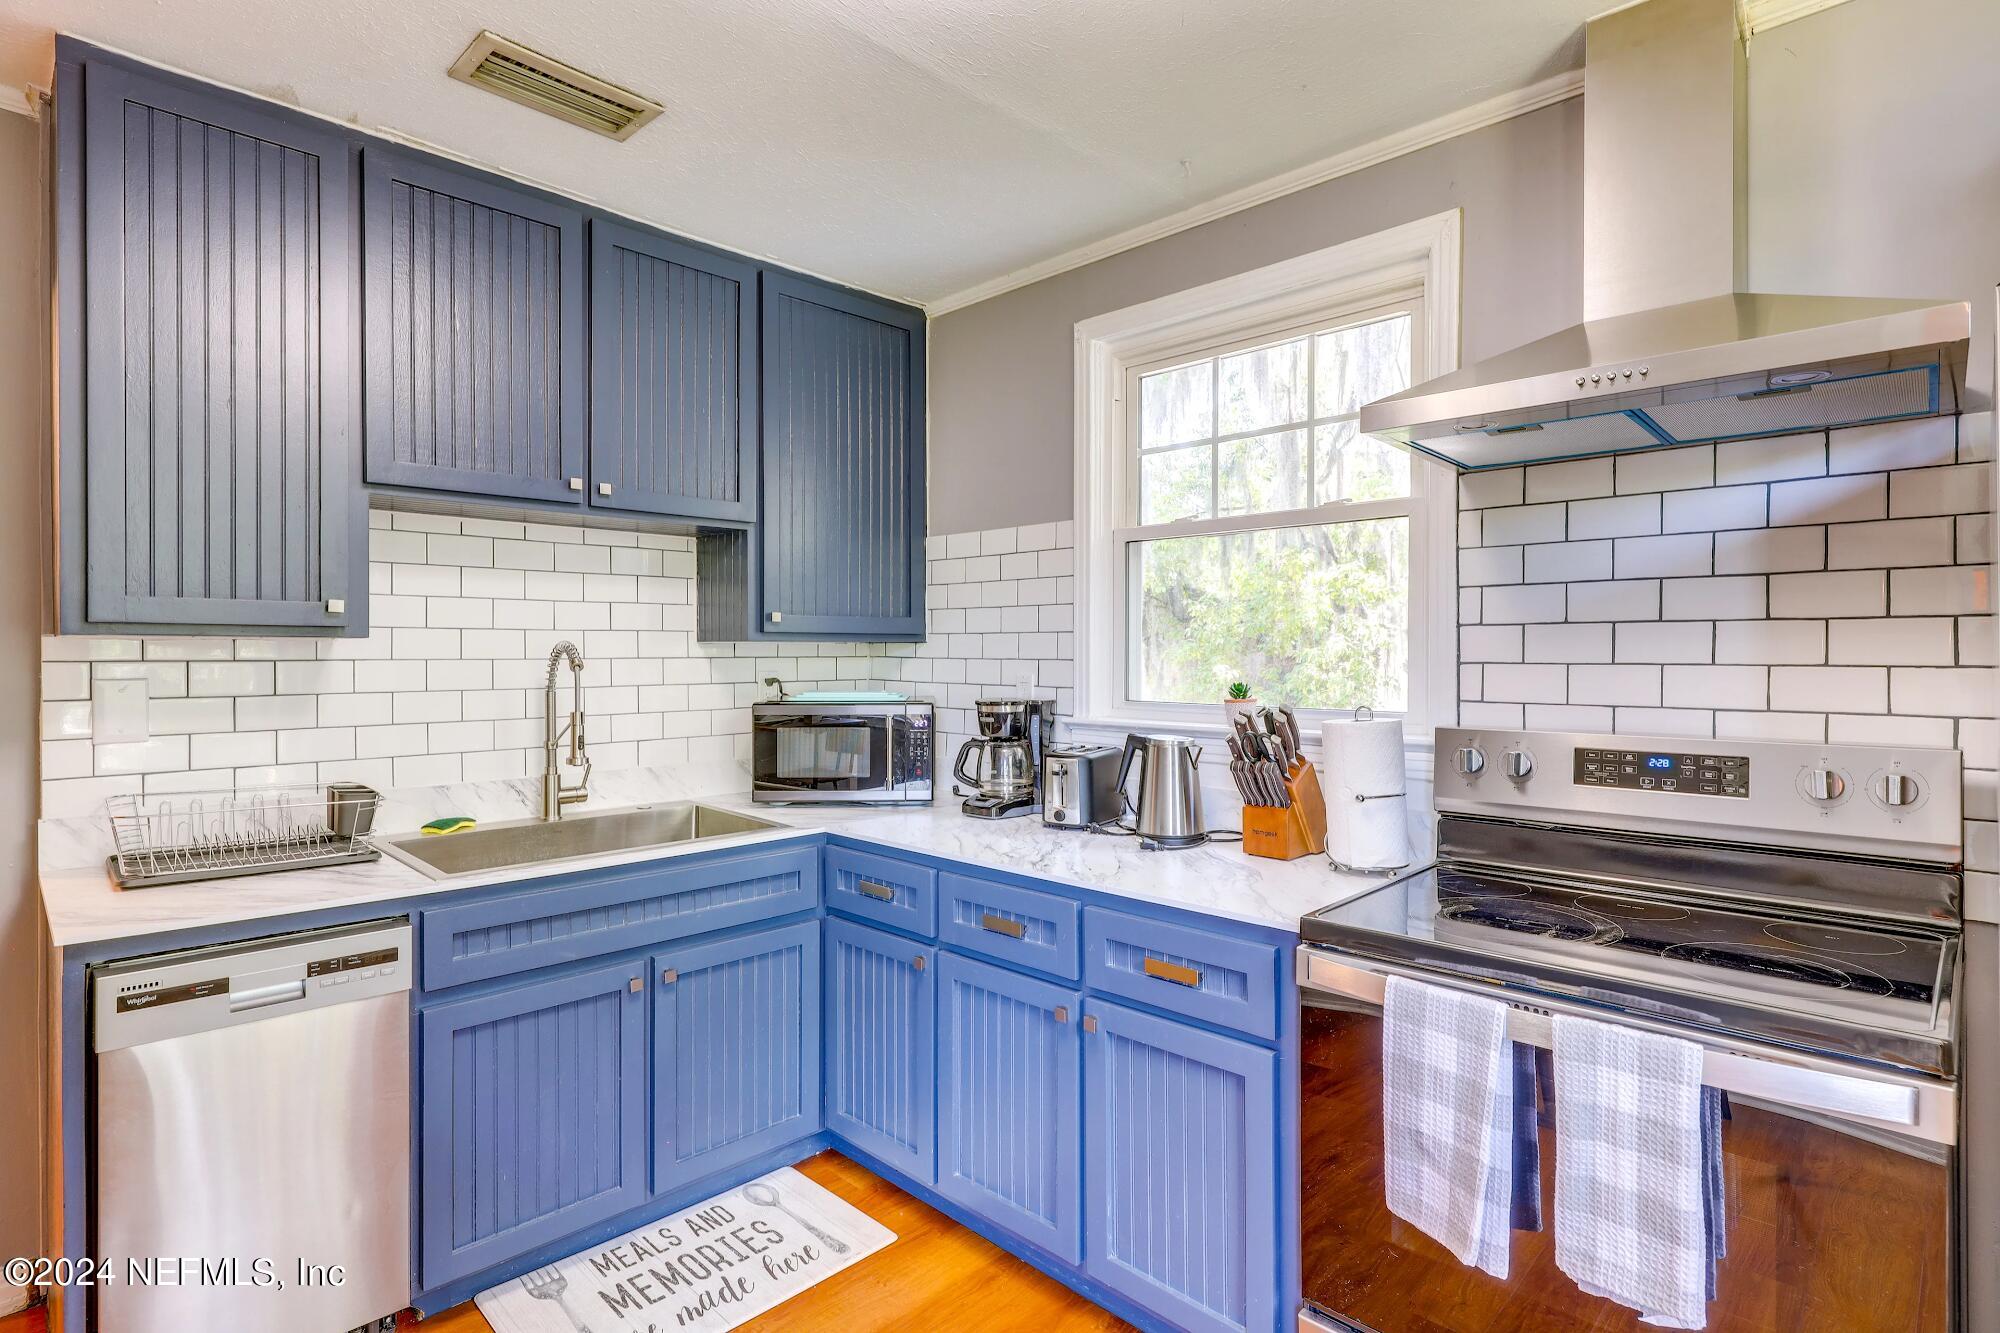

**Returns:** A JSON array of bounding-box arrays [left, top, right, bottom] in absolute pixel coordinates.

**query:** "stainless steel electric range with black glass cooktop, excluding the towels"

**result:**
[[1298, 729, 1964, 1333]]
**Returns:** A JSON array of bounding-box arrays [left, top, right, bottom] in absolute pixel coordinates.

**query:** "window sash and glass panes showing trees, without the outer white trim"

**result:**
[[1116, 302, 1422, 713]]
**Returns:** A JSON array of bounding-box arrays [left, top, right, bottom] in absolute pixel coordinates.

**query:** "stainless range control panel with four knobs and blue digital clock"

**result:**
[[1436, 727, 1964, 865]]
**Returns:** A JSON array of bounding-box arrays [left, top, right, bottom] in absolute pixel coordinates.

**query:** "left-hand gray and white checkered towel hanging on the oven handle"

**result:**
[[1382, 977, 1514, 1277]]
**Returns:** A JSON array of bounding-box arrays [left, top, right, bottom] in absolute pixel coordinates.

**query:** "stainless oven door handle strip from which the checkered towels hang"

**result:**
[[1298, 945, 1958, 1143]]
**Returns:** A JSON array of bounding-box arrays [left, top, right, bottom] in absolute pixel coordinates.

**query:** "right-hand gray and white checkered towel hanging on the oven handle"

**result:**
[[1554, 1015, 1710, 1329]]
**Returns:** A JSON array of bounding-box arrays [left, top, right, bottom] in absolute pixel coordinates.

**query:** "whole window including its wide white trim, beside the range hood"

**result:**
[[1078, 214, 1456, 741]]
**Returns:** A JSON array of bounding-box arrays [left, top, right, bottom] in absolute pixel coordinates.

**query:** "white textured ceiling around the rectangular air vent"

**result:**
[[0, 0, 1606, 302]]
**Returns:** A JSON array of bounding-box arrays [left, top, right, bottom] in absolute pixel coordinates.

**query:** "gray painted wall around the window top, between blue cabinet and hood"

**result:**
[[930, 98, 1584, 532]]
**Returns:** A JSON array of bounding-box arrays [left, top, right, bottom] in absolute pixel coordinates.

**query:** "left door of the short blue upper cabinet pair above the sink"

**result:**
[[362, 146, 586, 504]]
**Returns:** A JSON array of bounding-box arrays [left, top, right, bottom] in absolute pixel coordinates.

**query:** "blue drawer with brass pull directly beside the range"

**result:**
[[1084, 907, 1278, 1041]]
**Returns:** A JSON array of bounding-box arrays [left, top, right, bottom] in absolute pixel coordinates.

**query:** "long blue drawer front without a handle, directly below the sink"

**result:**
[[424, 847, 820, 991]]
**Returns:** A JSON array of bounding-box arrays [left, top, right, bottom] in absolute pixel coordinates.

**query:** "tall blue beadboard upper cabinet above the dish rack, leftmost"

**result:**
[[56, 49, 366, 634]]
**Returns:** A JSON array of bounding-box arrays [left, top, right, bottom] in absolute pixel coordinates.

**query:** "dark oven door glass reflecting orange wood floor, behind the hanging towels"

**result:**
[[1300, 997, 1952, 1333]]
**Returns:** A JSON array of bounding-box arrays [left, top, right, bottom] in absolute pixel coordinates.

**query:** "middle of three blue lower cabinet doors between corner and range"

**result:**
[[938, 953, 1082, 1263]]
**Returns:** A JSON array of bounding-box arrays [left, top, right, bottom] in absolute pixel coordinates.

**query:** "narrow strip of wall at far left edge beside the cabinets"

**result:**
[[0, 114, 50, 1309]]
